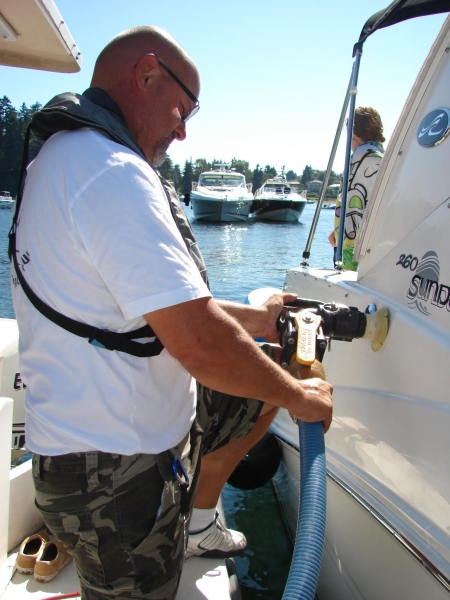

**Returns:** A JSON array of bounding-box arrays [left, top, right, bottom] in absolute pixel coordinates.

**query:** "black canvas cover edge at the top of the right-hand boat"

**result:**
[[353, 0, 450, 56]]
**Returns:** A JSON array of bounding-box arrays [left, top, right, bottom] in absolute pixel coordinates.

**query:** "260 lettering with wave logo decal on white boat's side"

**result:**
[[396, 250, 450, 317]]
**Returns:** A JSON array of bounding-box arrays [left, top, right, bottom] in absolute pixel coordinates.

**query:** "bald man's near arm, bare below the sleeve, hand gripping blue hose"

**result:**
[[144, 298, 333, 431]]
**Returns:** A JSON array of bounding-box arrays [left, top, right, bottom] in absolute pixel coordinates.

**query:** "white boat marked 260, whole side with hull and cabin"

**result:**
[[266, 18, 450, 600]]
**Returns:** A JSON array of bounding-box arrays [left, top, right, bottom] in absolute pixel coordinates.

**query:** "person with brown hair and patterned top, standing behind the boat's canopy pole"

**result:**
[[328, 106, 385, 271]]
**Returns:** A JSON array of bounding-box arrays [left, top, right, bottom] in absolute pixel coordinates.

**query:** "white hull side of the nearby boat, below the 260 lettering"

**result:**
[[272, 268, 450, 600]]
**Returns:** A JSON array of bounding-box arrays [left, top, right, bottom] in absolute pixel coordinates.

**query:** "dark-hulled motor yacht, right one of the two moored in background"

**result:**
[[250, 174, 306, 223]]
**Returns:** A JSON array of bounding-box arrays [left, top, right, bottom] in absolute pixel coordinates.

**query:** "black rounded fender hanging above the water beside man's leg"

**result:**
[[228, 431, 281, 490]]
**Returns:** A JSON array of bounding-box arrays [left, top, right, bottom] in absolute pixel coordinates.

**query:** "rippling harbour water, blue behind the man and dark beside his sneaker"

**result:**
[[0, 204, 334, 600]]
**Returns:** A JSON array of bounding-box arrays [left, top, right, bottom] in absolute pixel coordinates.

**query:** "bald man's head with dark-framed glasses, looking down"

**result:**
[[91, 26, 200, 166]]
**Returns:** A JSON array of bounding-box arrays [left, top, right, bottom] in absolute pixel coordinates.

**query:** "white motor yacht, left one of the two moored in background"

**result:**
[[190, 164, 253, 223]]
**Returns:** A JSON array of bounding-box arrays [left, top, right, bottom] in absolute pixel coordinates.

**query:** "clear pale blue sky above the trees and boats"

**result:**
[[0, 0, 445, 173]]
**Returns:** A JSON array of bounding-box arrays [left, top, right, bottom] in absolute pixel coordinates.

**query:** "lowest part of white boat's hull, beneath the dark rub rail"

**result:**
[[272, 424, 448, 600]]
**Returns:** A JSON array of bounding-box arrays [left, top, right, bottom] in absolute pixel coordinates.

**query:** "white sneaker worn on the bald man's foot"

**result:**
[[186, 512, 247, 558]]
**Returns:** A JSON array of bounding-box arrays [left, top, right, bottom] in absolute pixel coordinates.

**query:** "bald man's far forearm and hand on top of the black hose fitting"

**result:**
[[216, 292, 297, 342]]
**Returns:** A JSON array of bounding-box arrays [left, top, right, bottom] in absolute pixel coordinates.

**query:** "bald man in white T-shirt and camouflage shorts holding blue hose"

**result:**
[[12, 27, 332, 600]]
